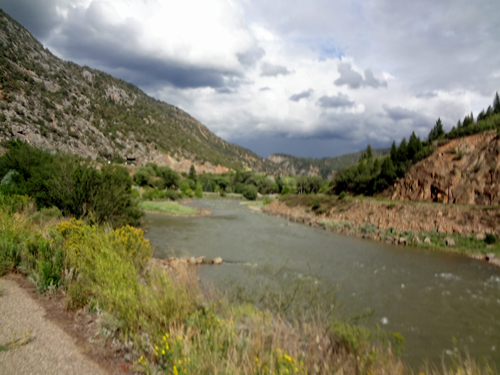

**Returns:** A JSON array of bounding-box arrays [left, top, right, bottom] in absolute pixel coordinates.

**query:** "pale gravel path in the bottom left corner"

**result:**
[[0, 278, 106, 375]]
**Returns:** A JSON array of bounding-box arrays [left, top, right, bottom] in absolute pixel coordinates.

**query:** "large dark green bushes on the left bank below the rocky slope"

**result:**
[[0, 141, 141, 227]]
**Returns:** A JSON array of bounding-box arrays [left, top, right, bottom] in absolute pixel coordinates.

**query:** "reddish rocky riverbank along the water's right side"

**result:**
[[262, 196, 500, 266]]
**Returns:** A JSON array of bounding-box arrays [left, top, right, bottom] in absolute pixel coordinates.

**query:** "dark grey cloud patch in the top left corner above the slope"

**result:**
[[0, 0, 63, 39]]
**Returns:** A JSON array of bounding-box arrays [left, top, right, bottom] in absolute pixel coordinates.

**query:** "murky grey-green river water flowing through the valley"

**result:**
[[146, 200, 500, 369]]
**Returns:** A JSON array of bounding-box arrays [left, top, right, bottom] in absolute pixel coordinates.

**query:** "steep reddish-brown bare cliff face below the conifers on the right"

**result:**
[[392, 132, 500, 205]]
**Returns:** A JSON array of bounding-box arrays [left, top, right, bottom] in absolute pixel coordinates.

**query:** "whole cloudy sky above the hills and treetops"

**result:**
[[0, 0, 500, 157]]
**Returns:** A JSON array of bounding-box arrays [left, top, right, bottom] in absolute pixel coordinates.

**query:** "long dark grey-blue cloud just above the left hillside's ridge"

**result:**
[[39, 3, 240, 89]]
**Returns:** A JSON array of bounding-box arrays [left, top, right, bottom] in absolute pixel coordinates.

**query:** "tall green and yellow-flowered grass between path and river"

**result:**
[[0, 198, 489, 375]]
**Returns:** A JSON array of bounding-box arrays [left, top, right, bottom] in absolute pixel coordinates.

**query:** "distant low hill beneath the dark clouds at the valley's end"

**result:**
[[267, 148, 390, 179]]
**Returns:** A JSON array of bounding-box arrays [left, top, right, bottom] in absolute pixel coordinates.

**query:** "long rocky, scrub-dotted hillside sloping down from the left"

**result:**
[[0, 11, 286, 173]]
